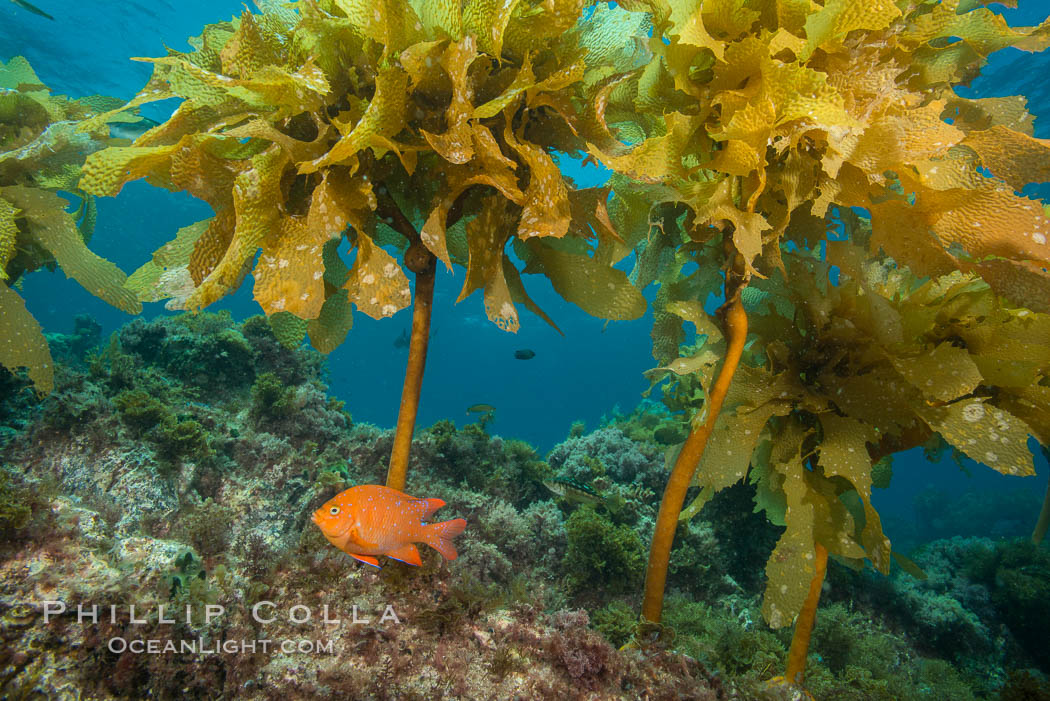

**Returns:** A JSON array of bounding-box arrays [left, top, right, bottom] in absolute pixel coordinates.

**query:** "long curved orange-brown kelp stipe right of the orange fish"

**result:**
[[642, 285, 748, 623]]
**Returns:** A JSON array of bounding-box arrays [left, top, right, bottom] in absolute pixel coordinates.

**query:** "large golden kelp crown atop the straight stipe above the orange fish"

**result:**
[[81, 0, 646, 351]]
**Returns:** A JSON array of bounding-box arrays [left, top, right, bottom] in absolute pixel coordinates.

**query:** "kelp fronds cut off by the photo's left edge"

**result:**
[[0, 57, 142, 394]]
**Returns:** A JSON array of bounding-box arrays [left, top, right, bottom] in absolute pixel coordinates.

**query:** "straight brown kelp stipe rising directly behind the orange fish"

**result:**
[[386, 243, 437, 491]]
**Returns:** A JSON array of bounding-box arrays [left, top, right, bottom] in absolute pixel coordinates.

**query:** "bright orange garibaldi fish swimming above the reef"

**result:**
[[306, 485, 466, 567]]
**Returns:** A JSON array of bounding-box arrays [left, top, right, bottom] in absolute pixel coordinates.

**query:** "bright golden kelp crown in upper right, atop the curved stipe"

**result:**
[[590, 0, 1050, 298]]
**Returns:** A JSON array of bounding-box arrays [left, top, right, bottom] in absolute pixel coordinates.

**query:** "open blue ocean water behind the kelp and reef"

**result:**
[[0, 0, 1050, 537]]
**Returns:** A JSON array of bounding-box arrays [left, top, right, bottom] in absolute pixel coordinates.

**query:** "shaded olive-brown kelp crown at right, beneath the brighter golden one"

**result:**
[[654, 224, 1050, 624]]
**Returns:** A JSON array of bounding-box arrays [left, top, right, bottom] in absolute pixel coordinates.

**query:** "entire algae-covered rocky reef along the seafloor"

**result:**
[[0, 313, 1050, 700]]
